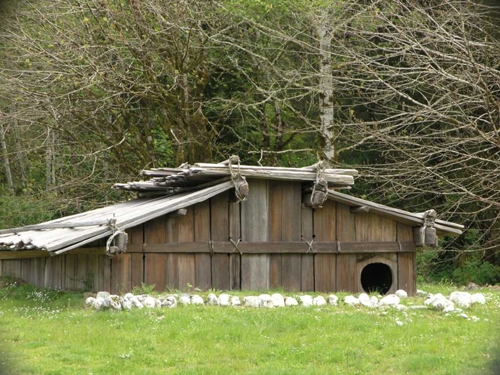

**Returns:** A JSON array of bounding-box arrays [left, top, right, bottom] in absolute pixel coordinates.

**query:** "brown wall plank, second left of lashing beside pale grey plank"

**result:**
[[194, 201, 212, 290]]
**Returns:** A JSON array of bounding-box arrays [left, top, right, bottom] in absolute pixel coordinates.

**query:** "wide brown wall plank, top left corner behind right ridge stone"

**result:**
[[314, 200, 337, 292]]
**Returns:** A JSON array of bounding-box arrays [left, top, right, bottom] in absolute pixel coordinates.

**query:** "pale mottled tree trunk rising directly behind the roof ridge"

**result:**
[[316, 9, 335, 161]]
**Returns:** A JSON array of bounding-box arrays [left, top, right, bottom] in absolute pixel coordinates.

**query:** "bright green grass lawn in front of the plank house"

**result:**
[[0, 285, 500, 375]]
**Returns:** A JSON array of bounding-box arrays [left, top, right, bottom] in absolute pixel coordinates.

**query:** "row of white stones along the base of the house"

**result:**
[[85, 290, 486, 312]]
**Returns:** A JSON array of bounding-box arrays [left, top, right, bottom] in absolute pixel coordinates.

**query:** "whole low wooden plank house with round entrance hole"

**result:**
[[0, 157, 463, 295]]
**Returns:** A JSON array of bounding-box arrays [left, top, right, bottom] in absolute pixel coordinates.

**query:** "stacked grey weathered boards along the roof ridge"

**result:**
[[113, 162, 358, 194]]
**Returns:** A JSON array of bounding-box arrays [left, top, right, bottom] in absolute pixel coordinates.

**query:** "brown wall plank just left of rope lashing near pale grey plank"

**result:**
[[210, 192, 231, 290]]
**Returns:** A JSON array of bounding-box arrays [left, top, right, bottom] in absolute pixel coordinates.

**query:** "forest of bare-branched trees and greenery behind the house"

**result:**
[[0, 0, 500, 284]]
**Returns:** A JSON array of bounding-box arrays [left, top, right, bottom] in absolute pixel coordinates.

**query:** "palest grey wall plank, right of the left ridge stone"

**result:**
[[241, 179, 270, 290]]
